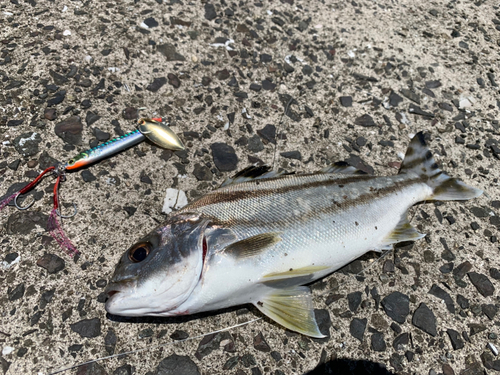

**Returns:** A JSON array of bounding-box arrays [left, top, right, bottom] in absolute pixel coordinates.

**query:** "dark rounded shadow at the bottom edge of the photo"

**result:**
[[304, 358, 395, 375]]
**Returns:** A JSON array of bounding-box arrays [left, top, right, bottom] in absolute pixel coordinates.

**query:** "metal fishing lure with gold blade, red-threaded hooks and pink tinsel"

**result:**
[[0, 118, 184, 256]]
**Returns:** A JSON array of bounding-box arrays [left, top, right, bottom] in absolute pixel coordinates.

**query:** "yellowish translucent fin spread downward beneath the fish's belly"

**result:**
[[254, 286, 326, 338]]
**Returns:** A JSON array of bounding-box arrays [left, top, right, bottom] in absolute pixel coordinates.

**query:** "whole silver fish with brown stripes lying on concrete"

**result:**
[[105, 132, 482, 338]]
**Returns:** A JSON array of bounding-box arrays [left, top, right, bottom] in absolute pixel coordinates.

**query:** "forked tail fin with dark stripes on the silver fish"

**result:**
[[399, 132, 483, 201]]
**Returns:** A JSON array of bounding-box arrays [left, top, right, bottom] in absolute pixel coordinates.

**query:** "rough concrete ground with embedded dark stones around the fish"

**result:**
[[0, 0, 500, 375]]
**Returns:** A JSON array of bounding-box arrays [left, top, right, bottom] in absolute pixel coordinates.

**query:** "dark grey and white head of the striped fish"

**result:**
[[106, 214, 208, 316]]
